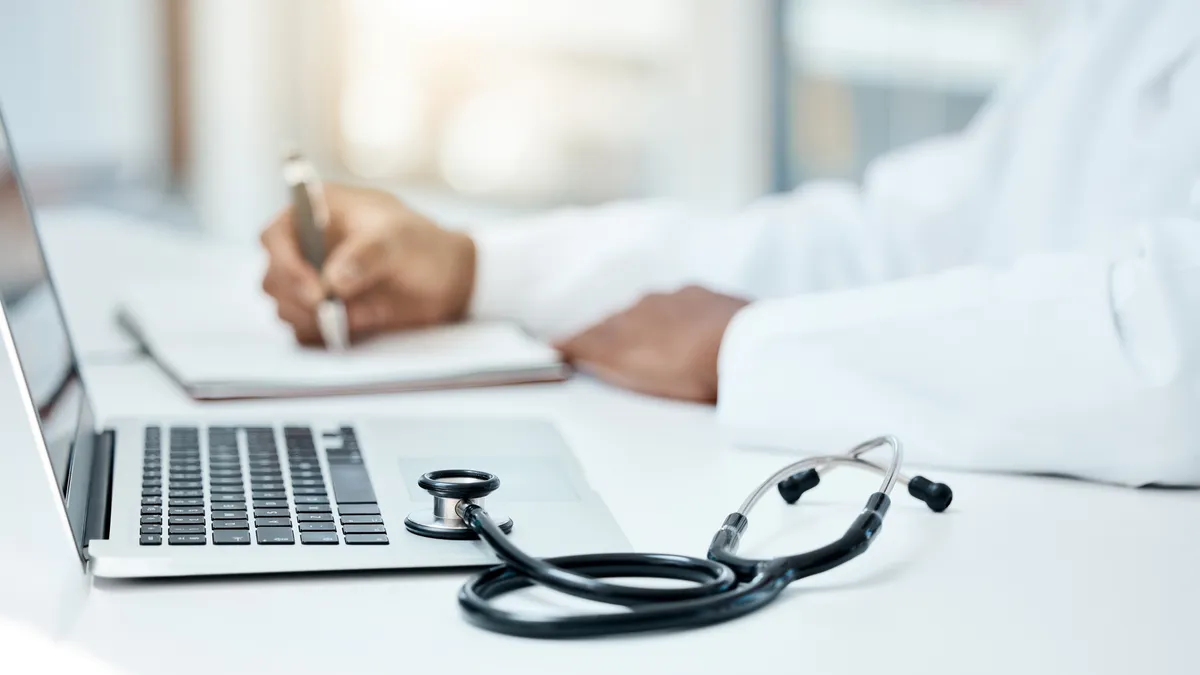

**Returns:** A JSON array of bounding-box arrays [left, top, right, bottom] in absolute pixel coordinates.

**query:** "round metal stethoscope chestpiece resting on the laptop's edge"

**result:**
[[404, 468, 512, 539]]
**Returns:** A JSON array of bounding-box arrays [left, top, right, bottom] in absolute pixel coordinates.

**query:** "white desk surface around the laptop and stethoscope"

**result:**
[[0, 207, 1200, 675]]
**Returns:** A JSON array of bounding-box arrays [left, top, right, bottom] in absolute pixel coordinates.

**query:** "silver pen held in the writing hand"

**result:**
[[283, 151, 350, 351]]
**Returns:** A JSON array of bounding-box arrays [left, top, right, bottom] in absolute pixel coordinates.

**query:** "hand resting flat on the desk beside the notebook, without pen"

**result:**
[[556, 286, 749, 402]]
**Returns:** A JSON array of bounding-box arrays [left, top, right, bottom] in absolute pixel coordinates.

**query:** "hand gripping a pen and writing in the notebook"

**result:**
[[262, 184, 475, 345]]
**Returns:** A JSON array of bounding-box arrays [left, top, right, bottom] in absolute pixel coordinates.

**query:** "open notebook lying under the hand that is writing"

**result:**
[[119, 279, 566, 399]]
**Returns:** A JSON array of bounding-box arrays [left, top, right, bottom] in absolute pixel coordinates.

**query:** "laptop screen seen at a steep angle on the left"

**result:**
[[0, 107, 94, 554]]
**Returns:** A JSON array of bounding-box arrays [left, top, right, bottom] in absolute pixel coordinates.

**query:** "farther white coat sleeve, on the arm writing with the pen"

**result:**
[[470, 129, 980, 336]]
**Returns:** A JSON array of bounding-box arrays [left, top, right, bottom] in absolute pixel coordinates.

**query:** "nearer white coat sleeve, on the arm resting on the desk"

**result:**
[[718, 219, 1200, 485]]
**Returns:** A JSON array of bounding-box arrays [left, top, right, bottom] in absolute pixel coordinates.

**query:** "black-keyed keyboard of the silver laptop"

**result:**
[[139, 426, 388, 546]]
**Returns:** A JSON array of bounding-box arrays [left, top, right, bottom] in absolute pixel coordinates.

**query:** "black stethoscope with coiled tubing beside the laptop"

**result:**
[[404, 436, 954, 638]]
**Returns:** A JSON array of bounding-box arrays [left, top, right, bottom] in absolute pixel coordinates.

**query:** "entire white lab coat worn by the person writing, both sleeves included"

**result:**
[[472, 0, 1200, 485]]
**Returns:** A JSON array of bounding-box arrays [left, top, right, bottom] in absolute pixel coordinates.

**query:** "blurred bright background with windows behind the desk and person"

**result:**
[[0, 0, 1057, 239]]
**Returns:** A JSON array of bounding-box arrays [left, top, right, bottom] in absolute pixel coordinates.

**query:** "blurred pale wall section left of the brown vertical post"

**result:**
[[0, 0, 168, 178]]
